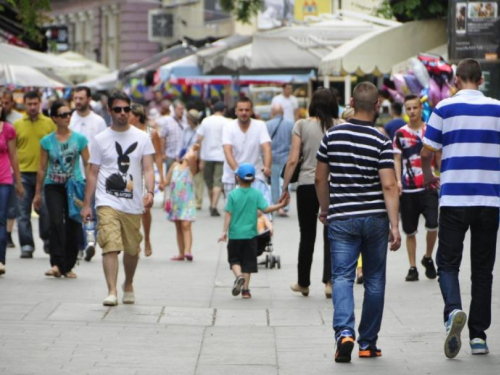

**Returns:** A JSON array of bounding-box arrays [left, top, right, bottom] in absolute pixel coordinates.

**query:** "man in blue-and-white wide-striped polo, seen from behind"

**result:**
[[421, 59, 500, 358]]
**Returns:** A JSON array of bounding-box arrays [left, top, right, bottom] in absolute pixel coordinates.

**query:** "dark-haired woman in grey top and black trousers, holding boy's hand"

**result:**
[[280, 88, 339, 298]]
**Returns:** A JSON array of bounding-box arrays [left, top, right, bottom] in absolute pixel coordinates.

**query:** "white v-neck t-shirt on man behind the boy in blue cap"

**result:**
[[222, 119, 271, 184]]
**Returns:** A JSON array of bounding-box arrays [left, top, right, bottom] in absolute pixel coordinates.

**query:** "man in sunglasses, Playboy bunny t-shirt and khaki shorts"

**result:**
[[81, 91, 155, 306]]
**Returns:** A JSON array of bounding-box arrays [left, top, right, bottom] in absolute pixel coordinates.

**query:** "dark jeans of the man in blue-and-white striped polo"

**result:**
[[436, 207, 499, 340]]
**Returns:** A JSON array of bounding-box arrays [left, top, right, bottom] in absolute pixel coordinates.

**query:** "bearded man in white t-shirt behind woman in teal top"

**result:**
[[69, 86, 107, 262]]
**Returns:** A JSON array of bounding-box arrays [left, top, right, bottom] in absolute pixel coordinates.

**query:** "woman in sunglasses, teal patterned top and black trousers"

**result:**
[[33, 101, 89, 279]]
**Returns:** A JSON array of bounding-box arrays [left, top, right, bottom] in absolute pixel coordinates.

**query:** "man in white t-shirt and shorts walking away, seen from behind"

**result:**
[[196, 102, 231, 216]]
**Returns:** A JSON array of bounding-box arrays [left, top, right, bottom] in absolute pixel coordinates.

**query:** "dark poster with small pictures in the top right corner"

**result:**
[[448, 0, 500, 61]]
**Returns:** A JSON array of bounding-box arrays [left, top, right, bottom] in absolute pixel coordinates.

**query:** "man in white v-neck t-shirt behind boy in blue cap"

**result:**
[[222, 98, 272, 202]]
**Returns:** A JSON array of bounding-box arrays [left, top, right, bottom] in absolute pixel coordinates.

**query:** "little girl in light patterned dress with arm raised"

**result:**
[[165, 144, 199, 261]]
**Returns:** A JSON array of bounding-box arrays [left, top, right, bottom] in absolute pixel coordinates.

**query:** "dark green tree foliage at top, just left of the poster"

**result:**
[[377, 0, 448, 22]]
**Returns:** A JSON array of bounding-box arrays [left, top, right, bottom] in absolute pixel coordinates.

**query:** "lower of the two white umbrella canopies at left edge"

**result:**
[[0, 65, 71, 88]]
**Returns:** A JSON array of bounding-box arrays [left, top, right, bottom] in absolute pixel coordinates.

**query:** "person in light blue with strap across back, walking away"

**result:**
[[266, 104, 294, 216]]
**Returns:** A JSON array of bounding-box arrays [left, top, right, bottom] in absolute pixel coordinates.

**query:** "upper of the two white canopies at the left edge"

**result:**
[[0, 43, 83, 69]]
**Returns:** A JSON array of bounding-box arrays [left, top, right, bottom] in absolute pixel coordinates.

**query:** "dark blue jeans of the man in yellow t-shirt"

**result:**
[[17, 172, 49, 251]]
